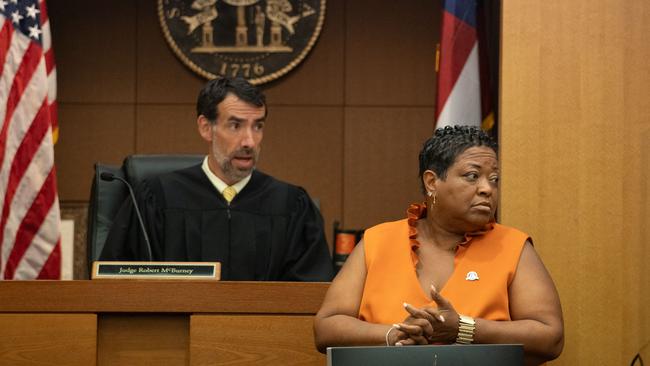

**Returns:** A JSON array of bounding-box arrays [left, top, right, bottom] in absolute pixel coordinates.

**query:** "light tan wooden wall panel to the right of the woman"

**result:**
[[500, 0, 650, 365]]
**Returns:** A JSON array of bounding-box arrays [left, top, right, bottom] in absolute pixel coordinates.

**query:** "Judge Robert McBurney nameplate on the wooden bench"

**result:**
[[90, 261, 221, 281]]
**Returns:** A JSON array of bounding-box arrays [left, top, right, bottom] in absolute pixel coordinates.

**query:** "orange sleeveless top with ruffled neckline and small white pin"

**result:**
[[358, 204, 529, 324]]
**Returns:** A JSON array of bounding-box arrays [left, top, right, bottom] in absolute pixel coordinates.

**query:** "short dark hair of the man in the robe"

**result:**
[[196, 77, 266, 123]]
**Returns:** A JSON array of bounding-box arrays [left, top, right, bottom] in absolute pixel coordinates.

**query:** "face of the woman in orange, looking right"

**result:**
[[427, 146, 499, 232]]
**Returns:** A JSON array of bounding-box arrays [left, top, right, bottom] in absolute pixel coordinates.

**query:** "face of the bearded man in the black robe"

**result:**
[[199, 94, 266, 185]]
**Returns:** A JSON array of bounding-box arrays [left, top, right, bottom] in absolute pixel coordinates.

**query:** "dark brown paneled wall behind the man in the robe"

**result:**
[[48, 0, 440, 249]]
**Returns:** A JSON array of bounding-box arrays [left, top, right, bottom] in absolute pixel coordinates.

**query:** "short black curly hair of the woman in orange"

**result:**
[[420, 126, 498, 193]]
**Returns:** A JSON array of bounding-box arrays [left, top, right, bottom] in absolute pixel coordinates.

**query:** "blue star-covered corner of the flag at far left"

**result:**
[[0, 0, 43, 43]]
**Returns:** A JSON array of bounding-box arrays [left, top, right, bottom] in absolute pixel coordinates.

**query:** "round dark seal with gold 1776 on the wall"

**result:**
[[158, 0, 326, 84]]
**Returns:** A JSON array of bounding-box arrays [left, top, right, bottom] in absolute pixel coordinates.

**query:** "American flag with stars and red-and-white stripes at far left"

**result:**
[[0, 0, 61, 279]]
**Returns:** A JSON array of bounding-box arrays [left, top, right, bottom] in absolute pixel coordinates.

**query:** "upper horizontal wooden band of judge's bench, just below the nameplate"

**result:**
[[0, 280, 329, 314]]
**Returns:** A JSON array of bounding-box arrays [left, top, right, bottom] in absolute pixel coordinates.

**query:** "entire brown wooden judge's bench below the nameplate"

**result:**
[[0, 280, 329, 366]]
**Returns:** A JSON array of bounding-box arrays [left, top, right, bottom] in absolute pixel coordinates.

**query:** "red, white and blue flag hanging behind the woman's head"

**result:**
[[436, 0, 483, 128]]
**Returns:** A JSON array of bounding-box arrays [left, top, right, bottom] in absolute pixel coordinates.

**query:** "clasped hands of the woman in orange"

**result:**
[[396, 286, 459, 346]]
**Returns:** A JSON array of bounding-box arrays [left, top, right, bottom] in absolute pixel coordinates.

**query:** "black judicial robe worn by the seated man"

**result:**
[[100, 165, 333, 281]]
